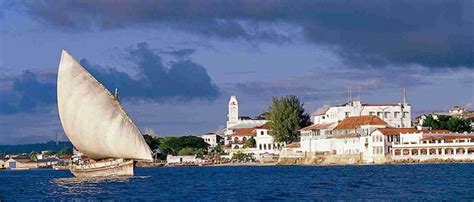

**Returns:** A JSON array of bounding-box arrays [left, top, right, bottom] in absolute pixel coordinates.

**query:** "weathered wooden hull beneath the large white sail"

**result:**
[[70, 159, 134, 177]]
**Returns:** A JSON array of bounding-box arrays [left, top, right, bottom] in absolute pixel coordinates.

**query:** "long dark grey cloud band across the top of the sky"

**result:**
[[20, 0, 474, 68]]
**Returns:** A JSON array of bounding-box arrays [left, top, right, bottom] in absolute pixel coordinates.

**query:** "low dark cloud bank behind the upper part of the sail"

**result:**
[[0, 43, 219, 114]]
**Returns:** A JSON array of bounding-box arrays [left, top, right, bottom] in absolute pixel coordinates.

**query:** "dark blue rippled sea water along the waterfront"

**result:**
[[0, 164, 474, 201]]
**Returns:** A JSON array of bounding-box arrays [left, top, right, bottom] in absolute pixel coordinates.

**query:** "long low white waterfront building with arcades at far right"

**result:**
[[391, 131, 474, 161]]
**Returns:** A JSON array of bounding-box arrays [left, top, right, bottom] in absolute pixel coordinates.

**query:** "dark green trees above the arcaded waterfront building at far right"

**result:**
[[423, 115, 472, 133]]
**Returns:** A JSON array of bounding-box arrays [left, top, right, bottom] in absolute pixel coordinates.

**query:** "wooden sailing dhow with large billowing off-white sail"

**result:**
[[57, 50, 153, 177]]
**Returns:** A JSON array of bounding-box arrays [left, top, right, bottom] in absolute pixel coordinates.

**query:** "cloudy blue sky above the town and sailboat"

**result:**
[[0, 0, 474, 144]]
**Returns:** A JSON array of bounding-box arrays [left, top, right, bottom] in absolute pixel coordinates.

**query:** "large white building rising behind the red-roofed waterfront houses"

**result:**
[[313, 90, 411, 128]]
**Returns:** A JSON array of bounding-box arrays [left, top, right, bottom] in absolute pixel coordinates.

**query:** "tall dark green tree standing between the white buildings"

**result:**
[[269, 95, 311, 143]]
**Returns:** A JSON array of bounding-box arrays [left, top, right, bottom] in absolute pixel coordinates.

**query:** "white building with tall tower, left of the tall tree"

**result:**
[[224, 96, 268, 147]]
